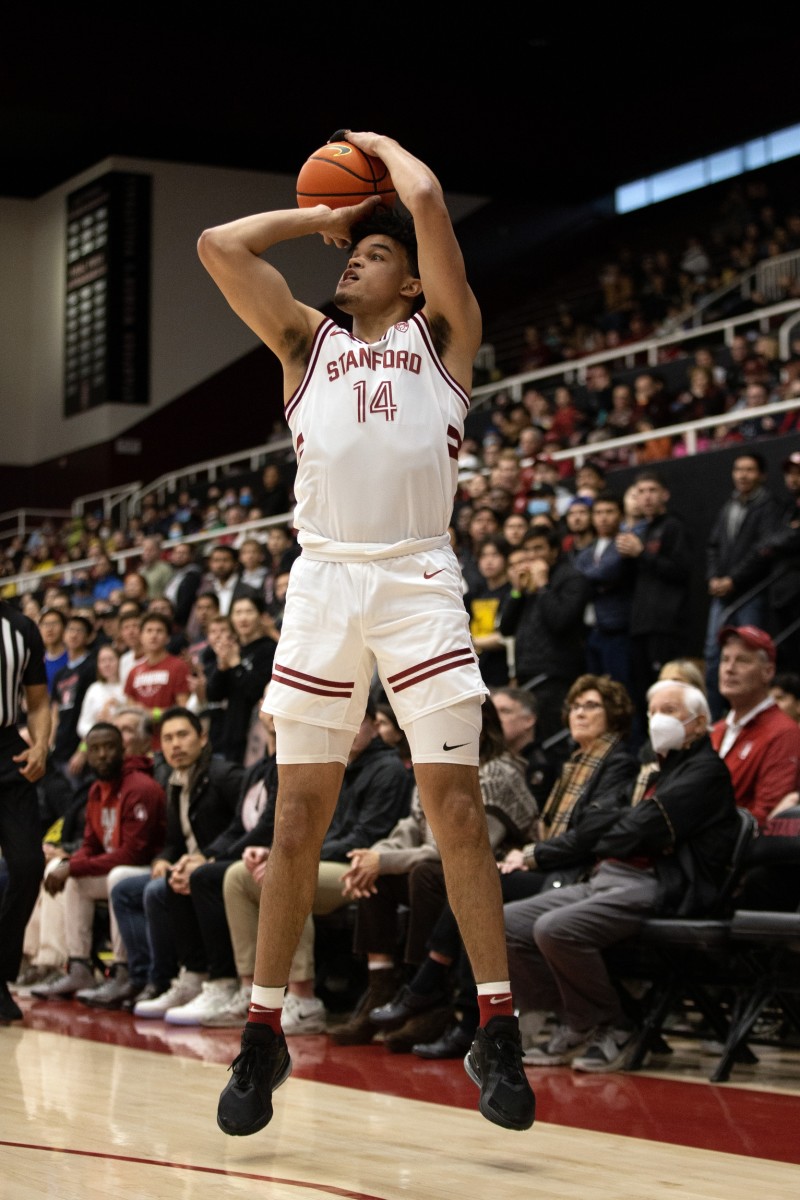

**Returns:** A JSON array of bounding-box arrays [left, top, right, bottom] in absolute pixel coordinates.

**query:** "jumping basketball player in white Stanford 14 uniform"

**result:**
[[198, 131, 535, 1134]]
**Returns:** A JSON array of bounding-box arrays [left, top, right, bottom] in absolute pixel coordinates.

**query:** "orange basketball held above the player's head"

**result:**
[[297, 142, 397, 209]]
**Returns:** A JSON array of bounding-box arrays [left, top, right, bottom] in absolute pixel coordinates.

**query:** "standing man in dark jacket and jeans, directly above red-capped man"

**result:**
[[704, 450, 781, 720]]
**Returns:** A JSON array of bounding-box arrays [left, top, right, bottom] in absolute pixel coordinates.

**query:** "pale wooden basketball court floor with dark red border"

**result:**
[[0, 998, 800, 1200]]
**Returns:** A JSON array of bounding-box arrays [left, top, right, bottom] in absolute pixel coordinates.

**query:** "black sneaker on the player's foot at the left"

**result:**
[[217, 1021, 291, 1136]]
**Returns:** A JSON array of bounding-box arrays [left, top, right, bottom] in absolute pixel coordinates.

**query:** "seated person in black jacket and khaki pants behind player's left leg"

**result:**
[[219, 700, 411, 1034]]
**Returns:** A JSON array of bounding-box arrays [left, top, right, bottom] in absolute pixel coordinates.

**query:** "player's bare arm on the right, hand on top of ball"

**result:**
[[345, 130, 482, 390]]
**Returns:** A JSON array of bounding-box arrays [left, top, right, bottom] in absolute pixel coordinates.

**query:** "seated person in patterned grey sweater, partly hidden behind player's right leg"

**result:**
[[331, 698, 536, 1054]]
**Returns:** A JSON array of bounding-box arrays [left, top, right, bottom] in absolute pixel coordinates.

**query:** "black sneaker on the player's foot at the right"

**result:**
[[464, 1016, 536, 1129]]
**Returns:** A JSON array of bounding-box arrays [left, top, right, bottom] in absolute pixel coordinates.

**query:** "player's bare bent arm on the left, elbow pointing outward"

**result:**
[[198, 197, 377, 392]]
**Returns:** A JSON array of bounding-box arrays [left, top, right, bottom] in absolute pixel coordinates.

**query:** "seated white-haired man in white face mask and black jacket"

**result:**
[[504, 679, 738, 1072]]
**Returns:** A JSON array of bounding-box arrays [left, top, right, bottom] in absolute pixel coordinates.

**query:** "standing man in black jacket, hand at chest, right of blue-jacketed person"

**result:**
[[615, 470, 692, 744]]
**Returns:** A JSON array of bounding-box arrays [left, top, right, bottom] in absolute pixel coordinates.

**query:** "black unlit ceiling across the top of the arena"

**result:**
[[6, 18, 800, 206]]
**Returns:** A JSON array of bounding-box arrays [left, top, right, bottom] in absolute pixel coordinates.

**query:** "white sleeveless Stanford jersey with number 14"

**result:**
[[285, 313, 469, 560]]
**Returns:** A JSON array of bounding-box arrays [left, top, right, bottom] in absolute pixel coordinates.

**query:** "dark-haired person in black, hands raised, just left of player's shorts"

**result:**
[[205, 593, 276, 763]]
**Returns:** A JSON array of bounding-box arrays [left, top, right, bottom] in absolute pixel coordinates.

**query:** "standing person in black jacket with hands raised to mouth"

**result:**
[[500, 529, 589, 738]]
